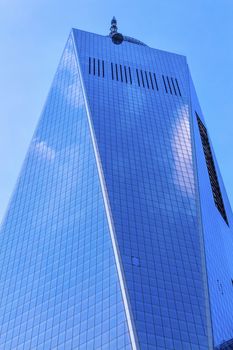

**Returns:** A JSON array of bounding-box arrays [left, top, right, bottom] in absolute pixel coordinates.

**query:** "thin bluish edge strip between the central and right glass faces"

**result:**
[[186, 62, 214, 350]]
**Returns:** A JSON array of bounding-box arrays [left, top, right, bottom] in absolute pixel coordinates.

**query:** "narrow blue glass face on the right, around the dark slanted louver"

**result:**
[[190, 78, 233, 345]]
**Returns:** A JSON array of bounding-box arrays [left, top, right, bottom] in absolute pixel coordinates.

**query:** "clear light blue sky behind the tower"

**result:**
[[0, 0, 233, 220]]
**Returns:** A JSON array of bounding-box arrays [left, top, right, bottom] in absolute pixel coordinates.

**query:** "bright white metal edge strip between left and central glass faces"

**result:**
[[72, 31, 139, 350]]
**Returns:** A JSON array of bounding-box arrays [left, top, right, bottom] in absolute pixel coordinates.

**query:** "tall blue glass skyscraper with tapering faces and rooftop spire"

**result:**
[[0, 18, 233, 350]]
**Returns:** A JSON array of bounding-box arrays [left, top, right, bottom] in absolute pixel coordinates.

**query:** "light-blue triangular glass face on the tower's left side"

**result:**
[[0, 37, 131, 350]]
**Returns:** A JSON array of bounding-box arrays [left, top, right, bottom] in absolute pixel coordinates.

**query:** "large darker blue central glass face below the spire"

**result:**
[[74, 31, 211, 350]]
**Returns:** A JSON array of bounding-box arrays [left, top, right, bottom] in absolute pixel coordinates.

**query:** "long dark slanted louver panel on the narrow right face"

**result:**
[[196, 113, 228, 225]]
